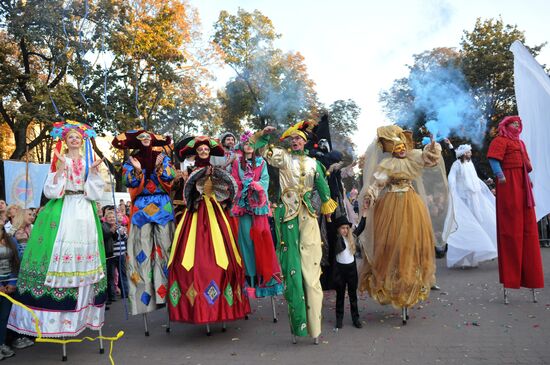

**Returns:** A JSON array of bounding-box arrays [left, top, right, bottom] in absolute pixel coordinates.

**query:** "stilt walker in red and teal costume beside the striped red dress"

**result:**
[[232, 131, 283, 322]]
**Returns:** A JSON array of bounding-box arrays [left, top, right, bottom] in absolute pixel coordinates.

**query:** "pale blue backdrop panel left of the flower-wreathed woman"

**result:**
[[3, 161, 50, 208]]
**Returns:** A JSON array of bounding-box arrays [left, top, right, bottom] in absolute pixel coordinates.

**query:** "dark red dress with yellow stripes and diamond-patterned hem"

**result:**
[[168, 167, 250, 324]]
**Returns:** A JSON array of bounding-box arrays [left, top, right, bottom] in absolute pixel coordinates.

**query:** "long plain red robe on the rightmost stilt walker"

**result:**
[[487, 136, 544, 288]]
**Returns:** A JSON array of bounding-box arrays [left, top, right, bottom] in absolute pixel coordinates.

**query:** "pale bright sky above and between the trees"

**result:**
[[190, 0, 550, 150]]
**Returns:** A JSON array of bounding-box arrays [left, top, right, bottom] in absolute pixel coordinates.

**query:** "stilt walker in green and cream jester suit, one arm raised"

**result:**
[[256, 122, 337, 344]]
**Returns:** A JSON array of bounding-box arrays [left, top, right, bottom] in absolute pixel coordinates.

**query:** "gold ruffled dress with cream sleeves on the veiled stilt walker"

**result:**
[[360, 144, 441, 308]]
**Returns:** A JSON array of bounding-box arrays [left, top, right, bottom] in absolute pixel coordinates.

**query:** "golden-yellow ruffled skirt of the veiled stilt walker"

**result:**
[[360, 189, 435, 308]]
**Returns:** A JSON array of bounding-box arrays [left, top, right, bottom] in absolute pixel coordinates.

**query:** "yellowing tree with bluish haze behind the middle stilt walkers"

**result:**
[[213, 9, 318, 132]]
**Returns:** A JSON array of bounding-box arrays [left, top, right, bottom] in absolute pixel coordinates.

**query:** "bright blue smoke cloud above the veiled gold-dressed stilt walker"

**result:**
[[403, 65, 486, 145]]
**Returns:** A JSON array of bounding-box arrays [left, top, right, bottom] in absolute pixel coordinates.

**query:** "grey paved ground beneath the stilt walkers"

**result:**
[[6, 248, 550, 365]]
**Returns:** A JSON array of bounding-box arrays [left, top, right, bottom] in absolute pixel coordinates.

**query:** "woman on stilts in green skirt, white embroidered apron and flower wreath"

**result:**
[[8, 120, 107, 360]]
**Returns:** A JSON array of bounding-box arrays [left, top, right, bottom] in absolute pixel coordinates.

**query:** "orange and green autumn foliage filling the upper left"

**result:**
[[0, 0, 219, 158]]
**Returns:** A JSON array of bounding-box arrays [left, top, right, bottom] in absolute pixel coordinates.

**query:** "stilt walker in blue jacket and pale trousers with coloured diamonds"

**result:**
[[113, 129, 175, 336]]
